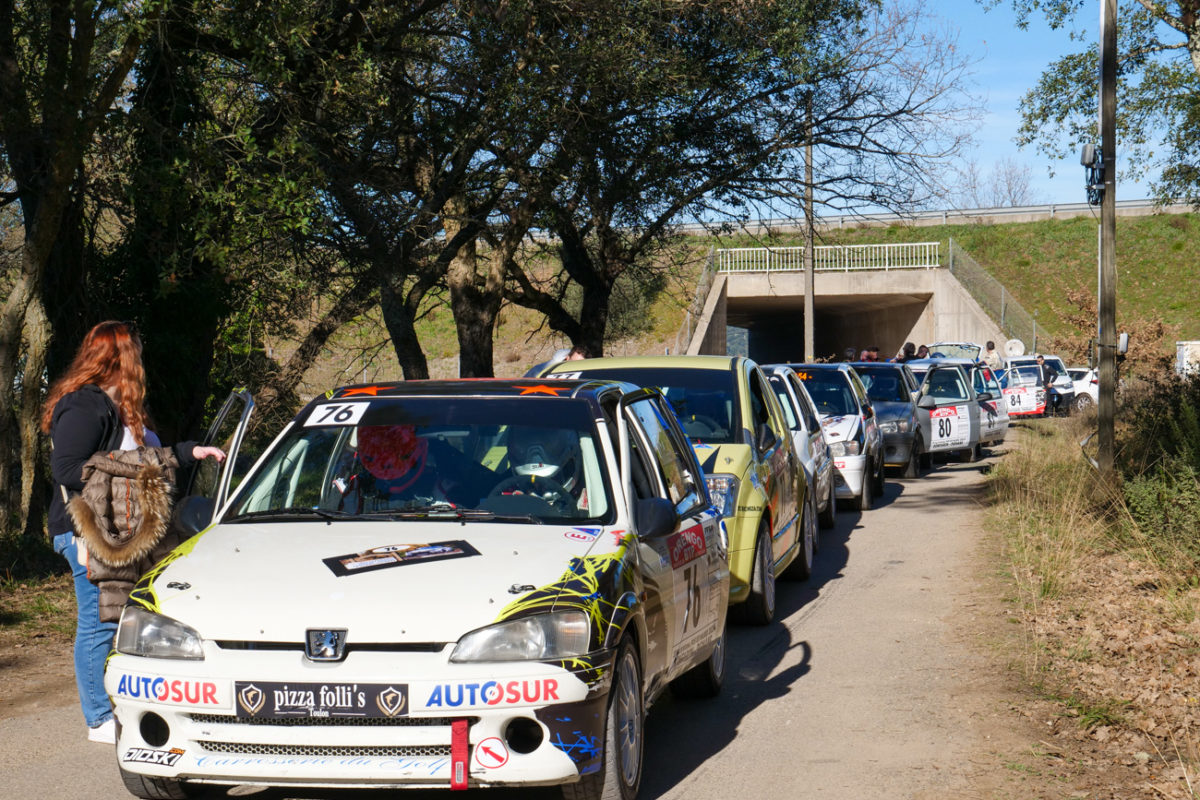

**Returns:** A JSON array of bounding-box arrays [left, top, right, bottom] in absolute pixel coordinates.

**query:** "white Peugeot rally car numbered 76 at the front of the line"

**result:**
[[104, 380, 730, 798]]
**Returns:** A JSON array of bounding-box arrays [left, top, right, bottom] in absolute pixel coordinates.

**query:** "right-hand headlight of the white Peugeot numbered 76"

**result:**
[[450, 609, 592, 663]]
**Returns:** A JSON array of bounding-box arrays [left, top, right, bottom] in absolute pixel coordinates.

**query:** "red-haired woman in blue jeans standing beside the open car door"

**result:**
[[42, 321, 224, 744]]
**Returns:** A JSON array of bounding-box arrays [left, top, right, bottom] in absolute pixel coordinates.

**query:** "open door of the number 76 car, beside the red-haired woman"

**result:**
[[179, 389, 254, 533]]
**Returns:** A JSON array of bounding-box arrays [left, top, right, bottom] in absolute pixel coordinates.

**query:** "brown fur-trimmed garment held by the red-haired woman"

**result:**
[[67, 447, 181, 622]]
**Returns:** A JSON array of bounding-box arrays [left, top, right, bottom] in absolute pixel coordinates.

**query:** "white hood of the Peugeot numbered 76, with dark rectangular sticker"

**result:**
[[145, 522, 622, 643]]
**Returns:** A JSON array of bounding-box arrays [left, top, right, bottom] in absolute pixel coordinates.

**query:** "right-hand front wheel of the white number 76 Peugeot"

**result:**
[[563, 638, 646, 800]]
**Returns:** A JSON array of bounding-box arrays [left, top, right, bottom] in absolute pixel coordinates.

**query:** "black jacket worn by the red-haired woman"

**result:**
[[49, 384, 196, 536]]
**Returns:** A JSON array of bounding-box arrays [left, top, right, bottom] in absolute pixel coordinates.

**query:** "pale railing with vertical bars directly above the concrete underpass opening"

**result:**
[[715, 241, 942, 272]]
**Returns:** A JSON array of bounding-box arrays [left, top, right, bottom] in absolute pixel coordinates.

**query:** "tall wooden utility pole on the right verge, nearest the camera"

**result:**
[[1097, 0, 1117, 479]]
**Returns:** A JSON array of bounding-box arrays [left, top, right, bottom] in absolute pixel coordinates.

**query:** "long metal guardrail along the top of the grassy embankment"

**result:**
[[677, 199, 1193, 234]]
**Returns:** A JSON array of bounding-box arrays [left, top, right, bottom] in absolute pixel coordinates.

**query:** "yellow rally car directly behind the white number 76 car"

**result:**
[[546, 355, 817, 625]]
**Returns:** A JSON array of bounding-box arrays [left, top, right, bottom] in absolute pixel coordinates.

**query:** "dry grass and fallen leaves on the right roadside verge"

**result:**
[[990, 419, 1200, 800]]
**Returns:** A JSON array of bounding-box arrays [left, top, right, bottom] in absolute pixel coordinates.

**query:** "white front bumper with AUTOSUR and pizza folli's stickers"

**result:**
[[104, 643, 600, 788]]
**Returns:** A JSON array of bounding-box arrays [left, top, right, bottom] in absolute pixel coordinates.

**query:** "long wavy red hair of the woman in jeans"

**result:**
[[42, 320, 148, 445]]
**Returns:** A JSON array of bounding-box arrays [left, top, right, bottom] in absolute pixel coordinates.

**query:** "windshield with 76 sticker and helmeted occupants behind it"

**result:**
[[224, 396, 612, 524]]
